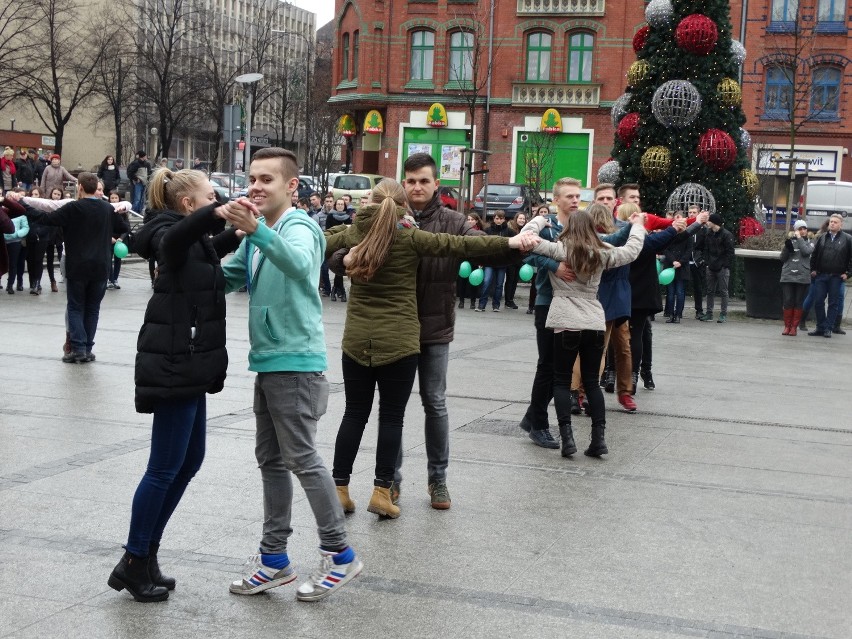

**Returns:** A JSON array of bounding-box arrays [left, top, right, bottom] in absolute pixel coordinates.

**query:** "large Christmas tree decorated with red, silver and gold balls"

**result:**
[[598, 0, 758, 228]]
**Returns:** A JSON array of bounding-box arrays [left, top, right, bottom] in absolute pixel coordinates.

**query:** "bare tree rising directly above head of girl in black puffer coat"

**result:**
[[125, 0, 209, 158]]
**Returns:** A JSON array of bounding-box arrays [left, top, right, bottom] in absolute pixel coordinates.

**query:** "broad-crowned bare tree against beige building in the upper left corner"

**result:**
[[9, 0, 104, 154]]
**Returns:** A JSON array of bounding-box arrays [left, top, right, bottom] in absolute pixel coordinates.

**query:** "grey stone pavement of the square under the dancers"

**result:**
[[0, 265, 852, 639]]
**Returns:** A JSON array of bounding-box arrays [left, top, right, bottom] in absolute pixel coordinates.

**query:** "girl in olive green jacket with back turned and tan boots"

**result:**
[[326, 180, 539, 517]]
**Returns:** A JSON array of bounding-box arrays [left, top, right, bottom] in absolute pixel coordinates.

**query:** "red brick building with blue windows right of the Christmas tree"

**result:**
[[743, 0, 852, 211]]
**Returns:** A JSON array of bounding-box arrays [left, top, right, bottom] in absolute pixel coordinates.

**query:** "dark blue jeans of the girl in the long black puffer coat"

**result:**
[[126, 395, 207, 557]]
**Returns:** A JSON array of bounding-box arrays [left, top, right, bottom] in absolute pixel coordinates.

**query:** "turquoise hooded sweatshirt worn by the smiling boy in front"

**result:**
[[222, 209, 328, 373]]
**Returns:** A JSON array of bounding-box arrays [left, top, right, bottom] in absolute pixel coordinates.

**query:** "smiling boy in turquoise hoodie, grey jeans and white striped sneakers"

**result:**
[[218, 148, 362, 601]]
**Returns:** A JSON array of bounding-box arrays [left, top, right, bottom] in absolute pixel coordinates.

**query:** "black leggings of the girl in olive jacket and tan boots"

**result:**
[[331, 353, 419, 488]]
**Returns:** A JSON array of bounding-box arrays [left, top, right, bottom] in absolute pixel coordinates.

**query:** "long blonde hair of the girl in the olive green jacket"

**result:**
[[346, 179, 408, 282]]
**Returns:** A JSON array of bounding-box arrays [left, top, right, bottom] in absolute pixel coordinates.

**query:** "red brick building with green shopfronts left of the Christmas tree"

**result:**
[[331, 0, 660, 198]]
